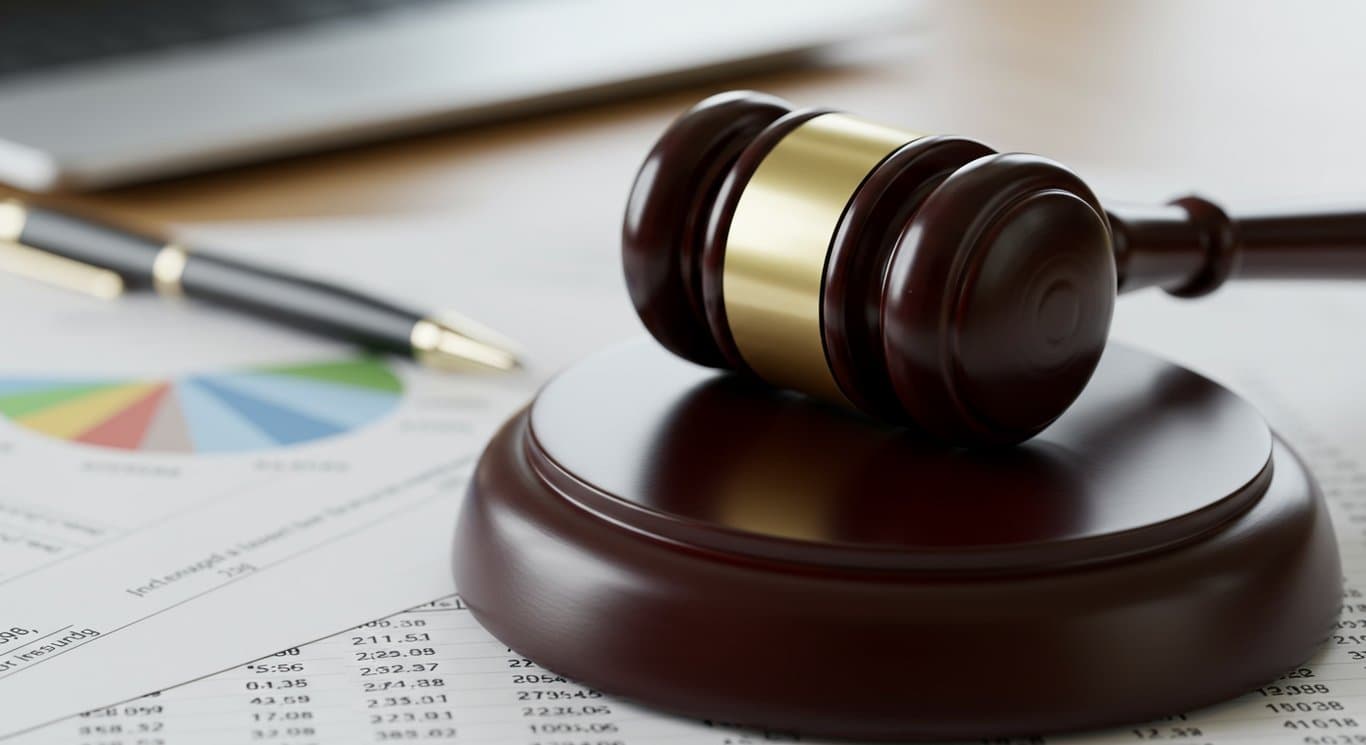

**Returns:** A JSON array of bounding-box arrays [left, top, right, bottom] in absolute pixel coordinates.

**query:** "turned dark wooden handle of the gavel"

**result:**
[[1106, 197, 1366, 298]]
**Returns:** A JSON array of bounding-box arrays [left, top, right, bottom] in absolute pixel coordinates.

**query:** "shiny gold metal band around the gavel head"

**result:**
[[721, 113, 919, 403]]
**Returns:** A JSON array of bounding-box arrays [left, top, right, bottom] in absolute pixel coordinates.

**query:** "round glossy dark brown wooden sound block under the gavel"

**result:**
[[454, 340, 1340, 738]]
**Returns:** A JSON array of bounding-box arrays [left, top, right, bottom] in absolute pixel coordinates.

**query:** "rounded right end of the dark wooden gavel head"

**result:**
[[881, 153, 1115, 444]]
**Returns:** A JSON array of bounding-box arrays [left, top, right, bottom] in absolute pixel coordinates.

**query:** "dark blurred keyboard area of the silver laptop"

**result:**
[[0, 0, 469, 78]]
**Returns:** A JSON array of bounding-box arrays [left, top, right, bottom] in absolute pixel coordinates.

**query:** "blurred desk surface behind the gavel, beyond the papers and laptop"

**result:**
[[8, 0, 1366, 223]]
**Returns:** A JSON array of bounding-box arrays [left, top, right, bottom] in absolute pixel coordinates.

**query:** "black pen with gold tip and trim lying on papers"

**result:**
[[0, 200, 519, 370]]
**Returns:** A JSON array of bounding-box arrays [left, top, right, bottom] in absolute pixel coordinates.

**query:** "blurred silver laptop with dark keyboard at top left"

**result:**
[[0, 0, 908, 191]]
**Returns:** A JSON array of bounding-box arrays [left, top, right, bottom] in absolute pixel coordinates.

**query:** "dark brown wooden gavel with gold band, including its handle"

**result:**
[[622, 92, 1366, 447]]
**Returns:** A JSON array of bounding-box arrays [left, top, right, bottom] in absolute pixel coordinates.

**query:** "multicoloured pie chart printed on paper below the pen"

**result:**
[[0, 357, 403, 452]]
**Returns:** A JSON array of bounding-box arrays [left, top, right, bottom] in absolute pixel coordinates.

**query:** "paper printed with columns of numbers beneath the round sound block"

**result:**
[[7, 283, 1366, 745]]
